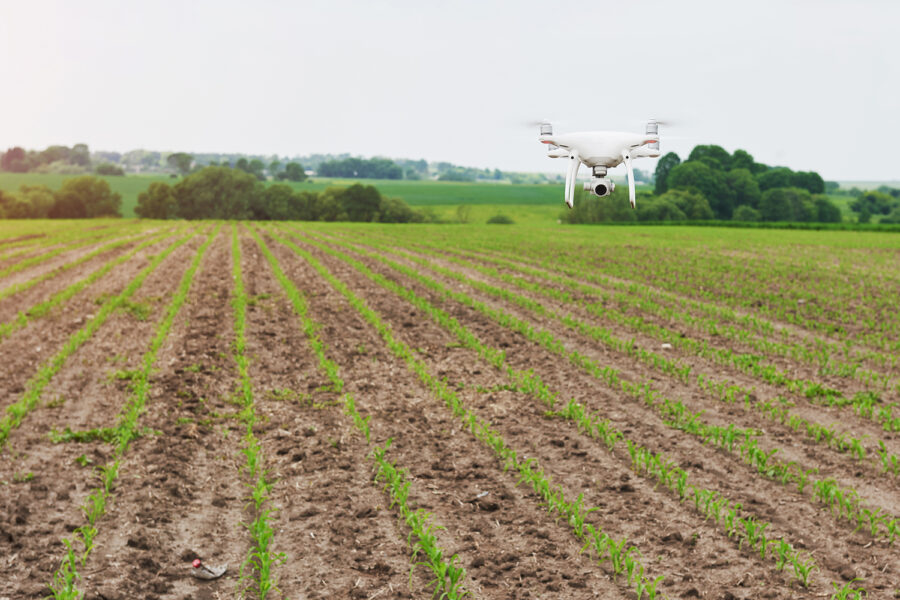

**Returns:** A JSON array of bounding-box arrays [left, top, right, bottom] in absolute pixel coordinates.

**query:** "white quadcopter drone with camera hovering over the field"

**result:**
[[538, 119, 659, 208]]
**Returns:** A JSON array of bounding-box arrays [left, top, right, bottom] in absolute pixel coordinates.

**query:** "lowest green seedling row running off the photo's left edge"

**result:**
[[0, 234, 195, 448]]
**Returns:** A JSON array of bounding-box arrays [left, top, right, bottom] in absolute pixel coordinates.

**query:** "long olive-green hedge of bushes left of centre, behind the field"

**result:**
[[135, 166, 426, 223]]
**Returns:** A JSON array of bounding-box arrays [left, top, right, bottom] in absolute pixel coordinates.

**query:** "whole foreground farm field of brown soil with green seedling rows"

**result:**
[[0, 221, 900, 600]]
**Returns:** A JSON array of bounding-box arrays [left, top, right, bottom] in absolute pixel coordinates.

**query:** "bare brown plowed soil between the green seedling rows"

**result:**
[[0, 224, 900, 600]]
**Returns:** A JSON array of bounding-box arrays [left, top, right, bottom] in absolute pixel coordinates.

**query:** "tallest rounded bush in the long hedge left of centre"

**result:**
[[173, 167, 263, 219]]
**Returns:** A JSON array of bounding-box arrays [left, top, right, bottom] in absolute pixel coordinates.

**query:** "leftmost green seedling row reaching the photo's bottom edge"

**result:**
[[47, 226, 221, 600]]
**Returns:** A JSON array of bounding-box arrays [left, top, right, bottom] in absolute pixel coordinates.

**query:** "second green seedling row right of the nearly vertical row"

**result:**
[[262, 225, 663, 600]]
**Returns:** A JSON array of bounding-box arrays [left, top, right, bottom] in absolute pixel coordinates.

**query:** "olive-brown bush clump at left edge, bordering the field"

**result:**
[[0, 175, 122, 219]]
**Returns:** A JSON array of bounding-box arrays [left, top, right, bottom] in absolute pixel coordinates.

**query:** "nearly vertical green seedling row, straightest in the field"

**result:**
[[231, 223, 286, 600]]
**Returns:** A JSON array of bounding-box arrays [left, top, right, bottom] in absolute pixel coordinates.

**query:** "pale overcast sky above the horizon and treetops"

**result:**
[[0, 0, 900, 181]]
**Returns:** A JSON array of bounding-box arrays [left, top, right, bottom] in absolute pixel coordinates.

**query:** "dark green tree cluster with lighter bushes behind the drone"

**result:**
[[563, 145, 841, 223]]
